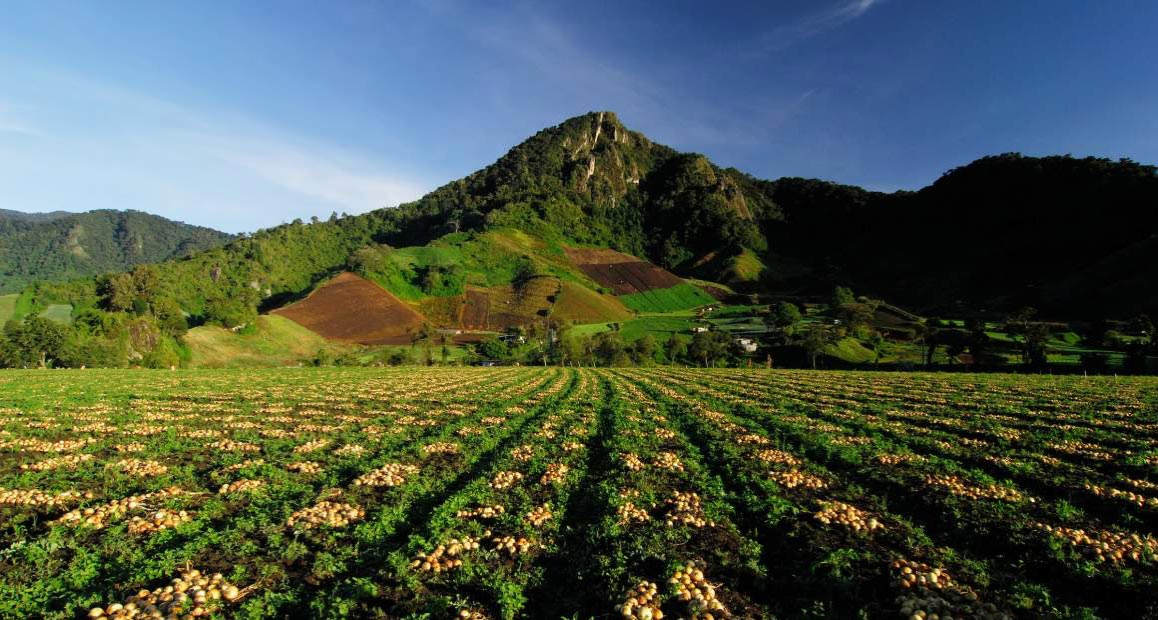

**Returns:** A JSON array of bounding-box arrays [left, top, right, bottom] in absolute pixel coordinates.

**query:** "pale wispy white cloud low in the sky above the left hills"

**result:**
[[0, 65, 428, 232]]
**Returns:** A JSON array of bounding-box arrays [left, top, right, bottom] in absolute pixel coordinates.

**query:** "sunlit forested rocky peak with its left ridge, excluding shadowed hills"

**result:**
[[20, 112, 778, 319]]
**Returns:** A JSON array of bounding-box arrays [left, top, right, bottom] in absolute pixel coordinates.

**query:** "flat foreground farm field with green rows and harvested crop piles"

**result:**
[[0, 367, 1158, 619]]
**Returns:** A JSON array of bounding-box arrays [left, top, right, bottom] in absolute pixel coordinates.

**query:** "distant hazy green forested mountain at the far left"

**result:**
[[0, 210, 232, 293]]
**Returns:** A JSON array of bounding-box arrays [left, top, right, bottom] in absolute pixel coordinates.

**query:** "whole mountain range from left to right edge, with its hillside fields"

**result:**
[[9, 112, 1158, 365]]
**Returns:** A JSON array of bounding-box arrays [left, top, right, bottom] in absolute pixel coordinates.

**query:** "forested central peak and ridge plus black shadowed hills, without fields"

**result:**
[[20, 112, 1158, 316]]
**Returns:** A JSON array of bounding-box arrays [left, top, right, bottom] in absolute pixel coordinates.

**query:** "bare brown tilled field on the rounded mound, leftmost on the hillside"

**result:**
[[273, 272, 423, 344]]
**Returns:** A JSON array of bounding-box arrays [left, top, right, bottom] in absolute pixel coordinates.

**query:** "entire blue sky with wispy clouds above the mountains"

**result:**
[[0, 0, 1158, 232]]
